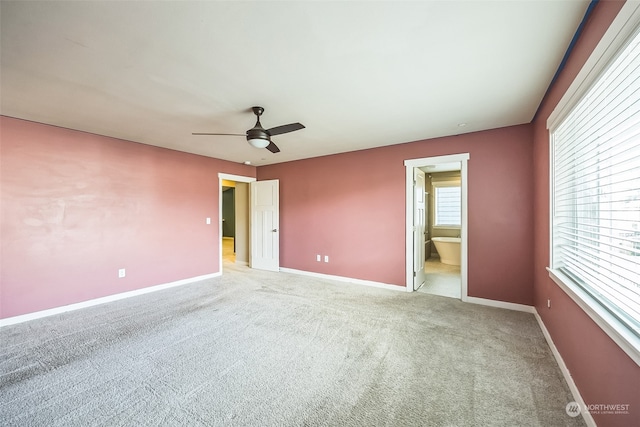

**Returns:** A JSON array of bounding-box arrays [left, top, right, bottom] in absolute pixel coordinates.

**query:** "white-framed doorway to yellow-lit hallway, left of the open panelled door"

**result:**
[[218, 173, 256, 272]]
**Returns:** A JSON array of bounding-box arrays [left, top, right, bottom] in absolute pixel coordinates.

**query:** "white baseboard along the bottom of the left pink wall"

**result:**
[[0, 272, 222, 328]]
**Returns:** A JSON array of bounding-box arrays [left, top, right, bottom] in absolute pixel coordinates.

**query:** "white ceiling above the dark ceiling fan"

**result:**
[[0, 0, 589, 165]]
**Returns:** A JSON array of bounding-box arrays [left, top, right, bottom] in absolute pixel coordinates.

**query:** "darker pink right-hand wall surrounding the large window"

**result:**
[[534, 1, 640, 426]]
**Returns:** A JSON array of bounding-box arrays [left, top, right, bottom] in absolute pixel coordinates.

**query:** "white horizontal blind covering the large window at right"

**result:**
[[551, 27, 640, 342]]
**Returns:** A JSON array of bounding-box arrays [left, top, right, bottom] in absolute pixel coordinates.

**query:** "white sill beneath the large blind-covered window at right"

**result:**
[[547, 267, 640, 366]]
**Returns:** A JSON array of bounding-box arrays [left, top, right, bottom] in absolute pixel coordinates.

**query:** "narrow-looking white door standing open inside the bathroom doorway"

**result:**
[[413, 168, 426, 291]]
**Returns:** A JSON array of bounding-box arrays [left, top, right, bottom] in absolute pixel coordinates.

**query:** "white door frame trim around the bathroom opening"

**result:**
[[404, 153, 469, 301]]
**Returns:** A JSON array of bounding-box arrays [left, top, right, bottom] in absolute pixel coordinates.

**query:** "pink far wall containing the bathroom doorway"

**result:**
[[258, 125, 533, 305]]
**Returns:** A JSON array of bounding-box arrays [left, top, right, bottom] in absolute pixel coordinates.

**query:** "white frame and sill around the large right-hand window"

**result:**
[[547, 1, 640, 365]]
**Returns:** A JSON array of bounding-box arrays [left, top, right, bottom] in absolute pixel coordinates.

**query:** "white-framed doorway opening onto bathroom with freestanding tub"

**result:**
[[405, 153, 469, 301]]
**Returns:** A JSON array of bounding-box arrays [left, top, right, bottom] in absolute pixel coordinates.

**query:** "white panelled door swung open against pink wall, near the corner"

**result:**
[[249, 179, 280, 271]]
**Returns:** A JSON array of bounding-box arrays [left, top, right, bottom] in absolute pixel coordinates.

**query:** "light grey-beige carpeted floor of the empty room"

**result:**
[[0, 264, 584, 427]]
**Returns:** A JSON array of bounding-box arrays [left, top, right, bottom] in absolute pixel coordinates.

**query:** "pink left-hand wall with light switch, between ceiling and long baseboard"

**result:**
[[0, 117, 255, 318]]
